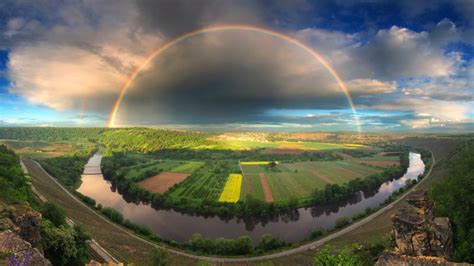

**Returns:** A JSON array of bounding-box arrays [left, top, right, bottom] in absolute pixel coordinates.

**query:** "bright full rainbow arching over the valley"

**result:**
[[108, 24, 362, 132]]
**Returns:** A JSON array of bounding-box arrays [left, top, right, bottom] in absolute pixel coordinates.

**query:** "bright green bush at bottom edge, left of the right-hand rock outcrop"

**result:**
[[314, 246, 364, 266]]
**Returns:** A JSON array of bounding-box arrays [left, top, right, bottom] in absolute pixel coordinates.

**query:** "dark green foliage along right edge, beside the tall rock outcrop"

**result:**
[[431, 141, 474, 263]]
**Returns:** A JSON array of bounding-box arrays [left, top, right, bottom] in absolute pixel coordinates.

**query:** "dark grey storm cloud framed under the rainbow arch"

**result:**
[[115, 33, 356, 123]]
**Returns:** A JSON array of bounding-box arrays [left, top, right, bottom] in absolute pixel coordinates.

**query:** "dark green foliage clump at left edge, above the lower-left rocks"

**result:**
[[0, 145, 31, 203]]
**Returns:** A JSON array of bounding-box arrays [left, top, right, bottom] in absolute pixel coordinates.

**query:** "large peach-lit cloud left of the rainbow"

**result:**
[[4, 2, 162, 111]]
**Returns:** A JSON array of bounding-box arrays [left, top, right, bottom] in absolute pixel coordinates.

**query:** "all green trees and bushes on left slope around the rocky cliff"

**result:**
[[0, 145, 91, 265]]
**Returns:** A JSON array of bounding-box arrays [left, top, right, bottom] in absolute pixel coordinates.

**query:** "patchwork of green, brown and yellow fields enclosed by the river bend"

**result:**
[[103, 140, 400, 206]]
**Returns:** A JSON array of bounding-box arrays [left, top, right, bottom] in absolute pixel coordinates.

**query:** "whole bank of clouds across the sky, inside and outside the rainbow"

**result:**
[[0, 0, 474, 128]]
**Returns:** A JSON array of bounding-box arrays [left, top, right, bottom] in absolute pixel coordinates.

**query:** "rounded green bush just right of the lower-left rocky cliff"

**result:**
[[41, 219, 90, 265]]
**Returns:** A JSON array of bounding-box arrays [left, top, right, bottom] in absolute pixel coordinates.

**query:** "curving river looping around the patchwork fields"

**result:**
[[78, 153, 425, 242]]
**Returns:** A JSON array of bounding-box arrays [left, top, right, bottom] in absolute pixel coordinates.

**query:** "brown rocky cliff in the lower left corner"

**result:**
[[0, 202, 51, 266]]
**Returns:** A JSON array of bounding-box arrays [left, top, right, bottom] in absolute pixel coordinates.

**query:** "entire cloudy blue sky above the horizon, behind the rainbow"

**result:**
[[0, 0, 474, 132]]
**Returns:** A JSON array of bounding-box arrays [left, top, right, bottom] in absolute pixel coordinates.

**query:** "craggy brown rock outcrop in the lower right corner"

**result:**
[[377, 191, 468, 265]]
